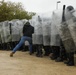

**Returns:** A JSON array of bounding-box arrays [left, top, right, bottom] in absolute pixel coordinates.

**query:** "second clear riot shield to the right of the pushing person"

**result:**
[[42, 18, 51, 46]]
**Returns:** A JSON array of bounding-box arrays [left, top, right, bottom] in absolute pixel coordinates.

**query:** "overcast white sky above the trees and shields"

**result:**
[[5, 0, 76, 13]]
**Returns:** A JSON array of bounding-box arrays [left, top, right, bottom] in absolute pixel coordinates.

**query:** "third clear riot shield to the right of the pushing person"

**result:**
[[50, 10, 60, 46]]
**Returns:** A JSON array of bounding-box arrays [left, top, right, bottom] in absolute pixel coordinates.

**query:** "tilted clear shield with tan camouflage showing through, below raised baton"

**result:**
[[57, 22, 75, 52]]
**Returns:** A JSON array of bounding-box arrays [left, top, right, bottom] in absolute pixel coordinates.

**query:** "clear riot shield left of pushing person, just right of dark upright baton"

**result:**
[[11, 20, 20, 42]]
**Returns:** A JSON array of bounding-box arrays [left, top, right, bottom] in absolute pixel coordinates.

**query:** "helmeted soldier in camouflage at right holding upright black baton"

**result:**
[[57, 5, 75, 66]]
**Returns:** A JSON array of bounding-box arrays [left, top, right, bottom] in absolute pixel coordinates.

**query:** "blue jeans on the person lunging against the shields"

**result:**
[[13, 36, 32, 52]]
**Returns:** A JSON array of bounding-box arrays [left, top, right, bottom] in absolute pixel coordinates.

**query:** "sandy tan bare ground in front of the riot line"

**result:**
[[0, 51, 76, 75]]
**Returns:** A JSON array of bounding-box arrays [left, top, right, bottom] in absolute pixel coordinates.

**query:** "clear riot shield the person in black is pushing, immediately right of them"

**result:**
[[32, 15, 43, 44]]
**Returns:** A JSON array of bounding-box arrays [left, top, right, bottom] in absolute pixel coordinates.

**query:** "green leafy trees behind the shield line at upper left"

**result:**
[[0, 0, 36, 22]]
